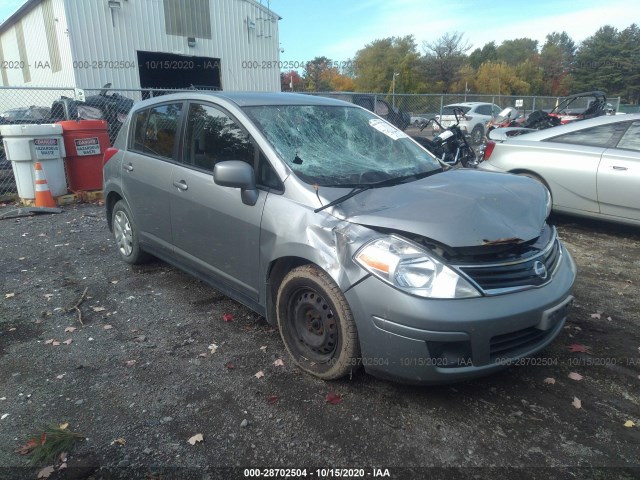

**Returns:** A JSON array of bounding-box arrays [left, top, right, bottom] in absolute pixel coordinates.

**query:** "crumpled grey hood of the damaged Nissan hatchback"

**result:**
[[337, 169, 546, 247]]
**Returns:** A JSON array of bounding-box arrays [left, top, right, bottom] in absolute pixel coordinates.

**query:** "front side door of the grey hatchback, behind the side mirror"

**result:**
[[170, 102, 267, 302]]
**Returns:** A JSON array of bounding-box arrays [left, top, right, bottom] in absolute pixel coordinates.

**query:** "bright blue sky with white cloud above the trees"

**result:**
[[0, 0, 640, 62]]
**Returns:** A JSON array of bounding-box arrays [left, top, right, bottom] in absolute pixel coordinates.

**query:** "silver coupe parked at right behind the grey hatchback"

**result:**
[[480, 114, 640, 225]]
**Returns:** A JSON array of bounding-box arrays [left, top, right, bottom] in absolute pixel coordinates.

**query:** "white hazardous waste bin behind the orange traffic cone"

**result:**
[[0, 124, 67, 199]]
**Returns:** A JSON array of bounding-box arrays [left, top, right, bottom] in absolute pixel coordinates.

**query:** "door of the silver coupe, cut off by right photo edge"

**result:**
[[598, 121, 640, 220]]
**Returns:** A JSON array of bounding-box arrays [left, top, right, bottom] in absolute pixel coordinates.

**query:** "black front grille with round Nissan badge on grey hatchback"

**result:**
[[458, 231, 562, 295]]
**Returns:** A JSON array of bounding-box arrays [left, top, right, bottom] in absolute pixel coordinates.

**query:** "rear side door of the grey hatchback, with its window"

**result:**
[[121, 102, 183, 253]]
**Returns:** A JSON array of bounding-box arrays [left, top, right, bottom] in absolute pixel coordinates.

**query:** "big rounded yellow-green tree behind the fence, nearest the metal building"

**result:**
[[354, 35, 424, 93]]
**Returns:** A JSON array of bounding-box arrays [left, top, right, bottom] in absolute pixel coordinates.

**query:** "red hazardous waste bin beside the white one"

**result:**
[[58, 120, 110, 192]]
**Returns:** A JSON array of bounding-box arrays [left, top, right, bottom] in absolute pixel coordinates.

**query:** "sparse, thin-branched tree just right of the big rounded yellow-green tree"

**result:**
[[422, 32, 471, 93]]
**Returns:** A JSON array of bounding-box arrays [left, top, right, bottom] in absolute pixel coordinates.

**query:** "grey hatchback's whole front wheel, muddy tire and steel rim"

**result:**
[[276, 265, 360, 380]]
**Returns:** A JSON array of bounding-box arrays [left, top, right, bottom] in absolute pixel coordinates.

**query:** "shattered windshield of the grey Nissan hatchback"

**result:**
[[245, 105, 441, 186]]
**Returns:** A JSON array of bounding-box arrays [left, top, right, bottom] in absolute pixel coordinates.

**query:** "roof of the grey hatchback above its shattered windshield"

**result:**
[[133, 90, 353, 107]]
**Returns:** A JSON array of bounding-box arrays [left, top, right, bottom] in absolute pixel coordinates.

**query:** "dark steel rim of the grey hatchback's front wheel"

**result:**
[[287, 288, 338, 362]]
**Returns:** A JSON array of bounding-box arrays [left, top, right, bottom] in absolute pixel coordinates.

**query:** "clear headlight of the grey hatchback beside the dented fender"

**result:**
[[354, 236, 480, 298]]
